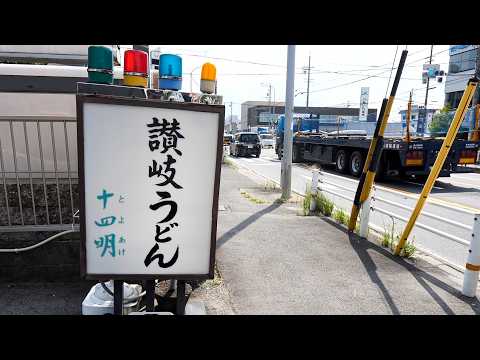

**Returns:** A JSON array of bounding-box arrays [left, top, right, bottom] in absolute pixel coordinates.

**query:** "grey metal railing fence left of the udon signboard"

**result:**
[[0, 117, 79, 233]]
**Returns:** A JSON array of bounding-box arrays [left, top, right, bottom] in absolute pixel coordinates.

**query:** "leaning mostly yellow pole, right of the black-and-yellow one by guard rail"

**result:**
[[395, 78, 478, 255]]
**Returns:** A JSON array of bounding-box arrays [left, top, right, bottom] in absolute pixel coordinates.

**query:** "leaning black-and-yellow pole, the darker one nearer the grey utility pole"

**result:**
[[348, 50, 408, 231]]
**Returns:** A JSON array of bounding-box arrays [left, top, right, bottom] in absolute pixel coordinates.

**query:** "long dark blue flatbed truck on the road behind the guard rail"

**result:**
[[275, 115, 479, 181]]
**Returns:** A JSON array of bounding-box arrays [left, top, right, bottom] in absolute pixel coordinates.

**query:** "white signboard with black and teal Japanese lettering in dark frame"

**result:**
[[77, 96, 224, 280]]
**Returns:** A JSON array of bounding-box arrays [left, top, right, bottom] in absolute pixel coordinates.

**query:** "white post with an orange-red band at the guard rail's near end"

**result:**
[[462, 214, 480, 297]]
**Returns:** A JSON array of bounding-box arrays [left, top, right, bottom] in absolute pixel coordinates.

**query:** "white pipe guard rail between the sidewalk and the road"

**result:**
[[311, 171, 480, 297]]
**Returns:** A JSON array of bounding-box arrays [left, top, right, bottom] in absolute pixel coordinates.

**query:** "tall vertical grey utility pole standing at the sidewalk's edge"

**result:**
[[281, 45, 295, 200]]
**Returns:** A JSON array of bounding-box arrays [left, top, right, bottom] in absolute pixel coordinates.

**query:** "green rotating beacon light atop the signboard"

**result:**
[[87, 45, 113, 84]]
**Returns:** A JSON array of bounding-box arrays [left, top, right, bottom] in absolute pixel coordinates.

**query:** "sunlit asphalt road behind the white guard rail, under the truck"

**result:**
[[230, 149, 480, 268]]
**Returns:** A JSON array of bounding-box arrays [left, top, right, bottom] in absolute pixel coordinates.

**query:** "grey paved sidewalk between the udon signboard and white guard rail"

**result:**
[[216, 165, 480, 314]]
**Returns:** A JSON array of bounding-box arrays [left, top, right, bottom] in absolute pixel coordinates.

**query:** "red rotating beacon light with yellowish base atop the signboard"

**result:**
[[123, 50, 148, 88]]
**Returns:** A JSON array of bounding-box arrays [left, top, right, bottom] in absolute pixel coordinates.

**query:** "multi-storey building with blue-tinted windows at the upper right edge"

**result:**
[[445, 45, 479, 109]]
